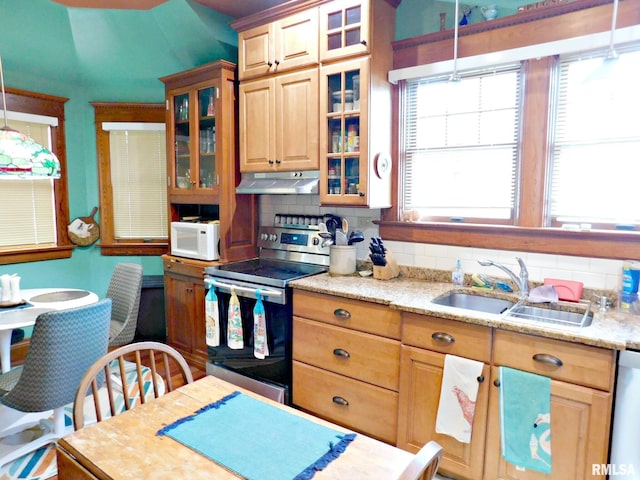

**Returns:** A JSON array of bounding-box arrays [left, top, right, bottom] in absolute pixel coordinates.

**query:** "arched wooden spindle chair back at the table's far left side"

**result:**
[[73, 342, 193, 430]]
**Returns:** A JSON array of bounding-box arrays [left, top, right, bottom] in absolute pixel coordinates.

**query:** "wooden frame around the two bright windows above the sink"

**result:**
[[376, 2, 640, 259]]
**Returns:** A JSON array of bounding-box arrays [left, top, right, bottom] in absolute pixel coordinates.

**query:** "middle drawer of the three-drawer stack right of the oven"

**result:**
[[293, 317, 400, 391]]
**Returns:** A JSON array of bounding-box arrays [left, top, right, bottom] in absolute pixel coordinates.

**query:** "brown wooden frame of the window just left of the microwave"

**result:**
[[90, 102, 169, 256]]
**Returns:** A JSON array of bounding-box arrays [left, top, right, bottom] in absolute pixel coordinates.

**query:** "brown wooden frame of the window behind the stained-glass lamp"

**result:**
[[0, 88, 74, 265]]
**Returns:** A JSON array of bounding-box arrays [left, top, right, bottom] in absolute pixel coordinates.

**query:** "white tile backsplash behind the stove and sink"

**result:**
[[259, 195, 623, 290]]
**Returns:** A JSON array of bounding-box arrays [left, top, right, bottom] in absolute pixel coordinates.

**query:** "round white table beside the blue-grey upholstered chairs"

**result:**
[[0, 287, 99, 373]]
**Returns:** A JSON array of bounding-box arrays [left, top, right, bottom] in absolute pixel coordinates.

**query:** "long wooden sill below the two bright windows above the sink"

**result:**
[[374, 221, 640, 260]]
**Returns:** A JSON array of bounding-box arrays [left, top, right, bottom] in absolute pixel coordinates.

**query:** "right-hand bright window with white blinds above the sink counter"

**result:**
[[548, 45, 640, 230]]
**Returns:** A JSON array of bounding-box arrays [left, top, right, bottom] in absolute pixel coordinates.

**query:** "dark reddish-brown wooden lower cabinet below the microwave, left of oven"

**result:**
[[164, 258, 207, 370]]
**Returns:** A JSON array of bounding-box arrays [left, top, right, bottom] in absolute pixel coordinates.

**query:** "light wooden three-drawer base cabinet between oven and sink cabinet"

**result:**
[[292, 290, 400, 444]]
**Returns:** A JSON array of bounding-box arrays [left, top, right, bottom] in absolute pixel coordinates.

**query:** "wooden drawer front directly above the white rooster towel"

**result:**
[[402, 313, 491, 363]]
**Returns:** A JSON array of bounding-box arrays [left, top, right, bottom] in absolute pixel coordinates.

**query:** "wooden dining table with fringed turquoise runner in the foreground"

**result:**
[[56, 375, 414, 480]]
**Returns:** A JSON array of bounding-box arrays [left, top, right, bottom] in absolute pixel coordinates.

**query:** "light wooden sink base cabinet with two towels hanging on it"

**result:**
[[397, 314, 615, 480]]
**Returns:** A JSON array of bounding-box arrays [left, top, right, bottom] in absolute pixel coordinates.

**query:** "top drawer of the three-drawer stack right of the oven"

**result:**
[[293, 290, 401, 340]]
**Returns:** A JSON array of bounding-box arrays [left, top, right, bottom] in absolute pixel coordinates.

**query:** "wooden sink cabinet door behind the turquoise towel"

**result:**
[[485, 367, 612, 480]]
